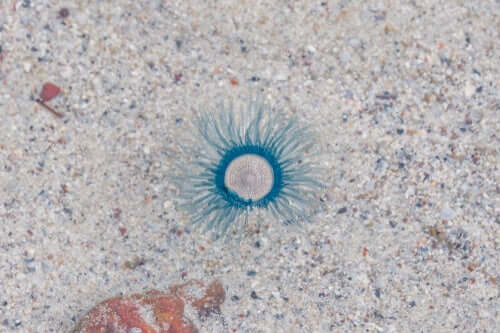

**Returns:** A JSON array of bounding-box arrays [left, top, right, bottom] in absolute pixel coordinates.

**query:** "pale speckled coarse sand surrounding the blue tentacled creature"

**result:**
[[0, 0, 500, 332]]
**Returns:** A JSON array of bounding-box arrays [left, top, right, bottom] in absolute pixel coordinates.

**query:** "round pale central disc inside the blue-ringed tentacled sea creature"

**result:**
[[224, 154, 274, 201]]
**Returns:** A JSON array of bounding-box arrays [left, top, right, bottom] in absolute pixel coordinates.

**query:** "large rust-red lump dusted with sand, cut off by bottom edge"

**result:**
[[74, 280, 225, 333]]
